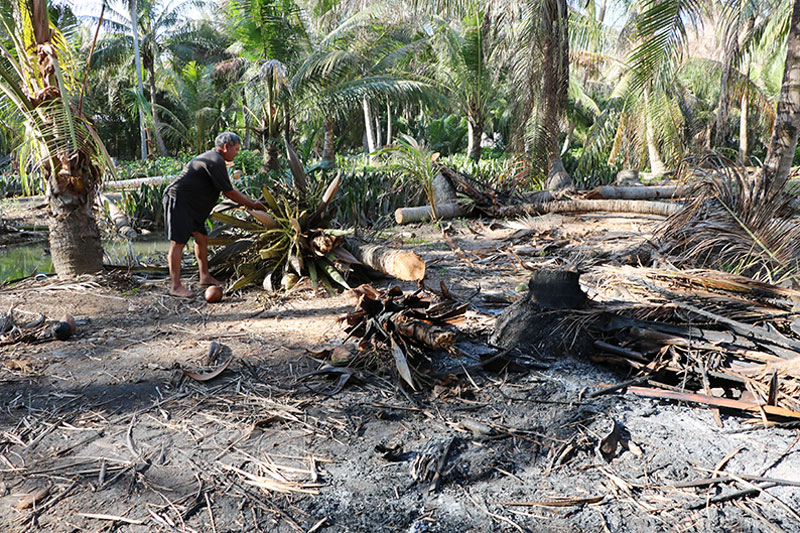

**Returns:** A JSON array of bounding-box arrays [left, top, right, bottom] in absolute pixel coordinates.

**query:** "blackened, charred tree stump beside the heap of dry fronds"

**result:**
[[489, 269, 592, 356]]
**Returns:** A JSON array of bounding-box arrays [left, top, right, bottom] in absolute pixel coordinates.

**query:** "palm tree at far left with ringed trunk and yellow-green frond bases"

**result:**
[[0, 0, 113, 276]]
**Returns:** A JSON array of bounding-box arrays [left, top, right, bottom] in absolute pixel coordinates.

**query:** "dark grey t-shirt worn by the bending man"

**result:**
[[164, 150, 233, 222]]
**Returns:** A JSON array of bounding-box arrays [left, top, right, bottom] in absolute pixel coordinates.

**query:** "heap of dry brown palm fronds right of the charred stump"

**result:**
[[584, 266, 800, 417]]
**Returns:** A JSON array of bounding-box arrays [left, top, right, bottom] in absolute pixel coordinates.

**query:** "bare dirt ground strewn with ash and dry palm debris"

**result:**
[[0, 202, 800, 533]]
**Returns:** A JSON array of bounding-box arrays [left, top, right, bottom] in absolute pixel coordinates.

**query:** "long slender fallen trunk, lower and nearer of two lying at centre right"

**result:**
[[490, 200, 683, 218]]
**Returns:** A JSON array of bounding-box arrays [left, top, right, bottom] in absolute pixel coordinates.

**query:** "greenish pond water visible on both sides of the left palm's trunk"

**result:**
[[0, 235, 169, 283]]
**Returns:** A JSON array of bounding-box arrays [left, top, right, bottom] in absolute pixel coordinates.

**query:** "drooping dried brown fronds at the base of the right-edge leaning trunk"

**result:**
[[656, 158, 800, 282]]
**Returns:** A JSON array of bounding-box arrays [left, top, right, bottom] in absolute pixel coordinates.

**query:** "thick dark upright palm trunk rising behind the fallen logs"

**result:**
[[541, 0, 572, 190]]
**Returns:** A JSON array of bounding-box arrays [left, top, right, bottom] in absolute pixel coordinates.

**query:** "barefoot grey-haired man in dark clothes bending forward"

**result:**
[[164, 132, 265, 298]]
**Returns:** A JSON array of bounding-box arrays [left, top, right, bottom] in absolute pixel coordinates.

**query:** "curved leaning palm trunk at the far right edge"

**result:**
[[754, 0, 800, 200]]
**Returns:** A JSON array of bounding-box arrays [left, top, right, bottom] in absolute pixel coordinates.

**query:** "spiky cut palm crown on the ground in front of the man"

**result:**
[[209, 139, 358, 292]]
